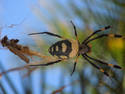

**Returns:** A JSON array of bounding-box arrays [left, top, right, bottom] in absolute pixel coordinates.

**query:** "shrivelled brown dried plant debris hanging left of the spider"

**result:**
[[1, 36, 47, 63]]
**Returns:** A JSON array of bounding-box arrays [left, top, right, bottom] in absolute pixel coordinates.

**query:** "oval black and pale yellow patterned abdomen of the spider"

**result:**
[[49, 39, 78, 59]]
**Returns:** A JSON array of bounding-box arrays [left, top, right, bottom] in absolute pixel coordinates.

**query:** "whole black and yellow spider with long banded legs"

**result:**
[[29, 21, 122, 76]]
